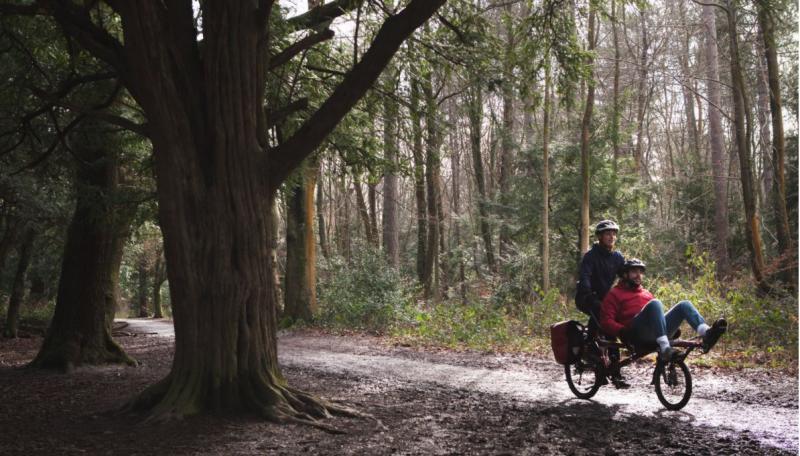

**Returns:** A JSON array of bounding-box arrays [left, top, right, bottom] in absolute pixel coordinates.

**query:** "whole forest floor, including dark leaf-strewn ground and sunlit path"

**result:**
[[0, 320, 798, 455]]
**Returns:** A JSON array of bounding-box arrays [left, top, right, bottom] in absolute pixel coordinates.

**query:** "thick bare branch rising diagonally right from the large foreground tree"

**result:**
[[265, 0, 445, 185]]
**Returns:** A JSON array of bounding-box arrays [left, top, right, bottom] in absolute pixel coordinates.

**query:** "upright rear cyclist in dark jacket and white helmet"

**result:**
[[575, 220, 629, 388]]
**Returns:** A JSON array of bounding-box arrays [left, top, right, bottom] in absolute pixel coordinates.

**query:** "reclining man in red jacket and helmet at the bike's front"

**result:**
[[600, 258, 728, 361]]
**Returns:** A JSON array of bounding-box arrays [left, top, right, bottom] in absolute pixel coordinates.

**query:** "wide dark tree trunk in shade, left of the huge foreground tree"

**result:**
[[32, 141, 135, 370]]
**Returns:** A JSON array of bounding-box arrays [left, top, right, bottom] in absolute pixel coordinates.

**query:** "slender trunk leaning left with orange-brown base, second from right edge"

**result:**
[[726, 0, 767, 288]]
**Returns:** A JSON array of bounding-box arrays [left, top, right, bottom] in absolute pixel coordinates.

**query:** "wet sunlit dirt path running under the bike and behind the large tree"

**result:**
[[115, 320, 798, 453]]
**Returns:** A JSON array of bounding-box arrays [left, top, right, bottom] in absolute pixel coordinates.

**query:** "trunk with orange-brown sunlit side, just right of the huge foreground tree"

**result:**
[[283, 159, 317, 322]]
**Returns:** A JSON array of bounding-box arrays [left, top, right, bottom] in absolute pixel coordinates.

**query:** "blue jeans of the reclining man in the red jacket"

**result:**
[[626, 299, 705, 344]]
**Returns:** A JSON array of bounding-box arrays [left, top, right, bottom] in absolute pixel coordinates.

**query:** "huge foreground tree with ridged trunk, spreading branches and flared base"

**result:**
[[39, 0, 444, 420]]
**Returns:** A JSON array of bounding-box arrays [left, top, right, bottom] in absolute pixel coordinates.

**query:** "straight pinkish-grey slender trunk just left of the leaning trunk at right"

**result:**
[[703, 5, 729, 278]]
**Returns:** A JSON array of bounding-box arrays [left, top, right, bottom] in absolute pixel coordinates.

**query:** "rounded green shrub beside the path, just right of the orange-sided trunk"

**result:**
[[317, 248, 411, 332]]
